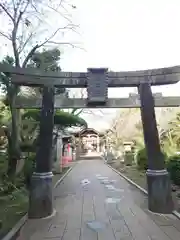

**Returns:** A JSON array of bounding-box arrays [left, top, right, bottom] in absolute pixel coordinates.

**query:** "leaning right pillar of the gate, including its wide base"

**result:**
[[138, 82, 173, 213]]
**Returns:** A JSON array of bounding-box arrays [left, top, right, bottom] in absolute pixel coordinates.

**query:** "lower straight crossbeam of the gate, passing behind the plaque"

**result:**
[[15, 95, 180, 109]]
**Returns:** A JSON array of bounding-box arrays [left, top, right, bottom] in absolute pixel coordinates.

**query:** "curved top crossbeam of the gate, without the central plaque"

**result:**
[[0, 64, 180, 88]]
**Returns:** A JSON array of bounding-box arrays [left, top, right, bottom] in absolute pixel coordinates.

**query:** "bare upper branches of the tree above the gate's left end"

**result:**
[[0, 0, 78, 67]]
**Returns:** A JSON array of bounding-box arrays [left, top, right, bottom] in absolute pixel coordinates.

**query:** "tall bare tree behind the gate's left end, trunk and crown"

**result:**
[[0, 0, 77, 175]]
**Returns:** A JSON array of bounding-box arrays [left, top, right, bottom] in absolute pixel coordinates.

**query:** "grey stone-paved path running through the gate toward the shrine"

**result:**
[[17, 160, 180, 240]]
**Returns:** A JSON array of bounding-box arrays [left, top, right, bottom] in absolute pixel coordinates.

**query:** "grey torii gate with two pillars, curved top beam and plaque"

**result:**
[[0, 64, 180, 218]]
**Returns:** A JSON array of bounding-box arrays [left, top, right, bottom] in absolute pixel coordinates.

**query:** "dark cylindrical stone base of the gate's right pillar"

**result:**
[[146, 169, 173, 214]]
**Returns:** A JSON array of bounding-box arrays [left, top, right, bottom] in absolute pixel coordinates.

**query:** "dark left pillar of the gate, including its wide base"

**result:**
[[28, 86, 54, 218]]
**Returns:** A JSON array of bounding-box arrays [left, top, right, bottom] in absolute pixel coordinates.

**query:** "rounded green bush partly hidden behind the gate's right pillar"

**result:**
[[136, 148, 167, 170]]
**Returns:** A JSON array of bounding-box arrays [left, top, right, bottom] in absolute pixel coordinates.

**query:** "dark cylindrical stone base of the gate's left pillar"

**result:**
[[28, 172, 53, 219]]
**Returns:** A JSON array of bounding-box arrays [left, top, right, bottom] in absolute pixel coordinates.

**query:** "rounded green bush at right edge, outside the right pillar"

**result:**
[[167, 155, 180, 185]]
